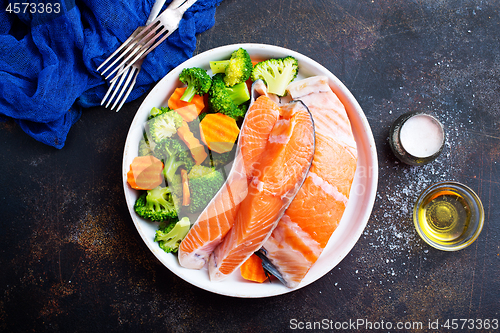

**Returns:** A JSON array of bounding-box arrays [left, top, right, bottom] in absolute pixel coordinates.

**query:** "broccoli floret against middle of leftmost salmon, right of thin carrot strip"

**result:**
[[188, 165, 225, 213]]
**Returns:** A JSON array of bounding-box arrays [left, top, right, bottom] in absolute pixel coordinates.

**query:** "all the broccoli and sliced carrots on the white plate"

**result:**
[[127, 48, 298, 274]]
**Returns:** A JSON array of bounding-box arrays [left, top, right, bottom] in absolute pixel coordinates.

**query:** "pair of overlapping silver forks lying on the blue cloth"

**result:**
[[97, 0, 197, 112]]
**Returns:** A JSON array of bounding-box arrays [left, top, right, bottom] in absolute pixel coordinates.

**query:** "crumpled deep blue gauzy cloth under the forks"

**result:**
[[0, 0, 222, 148]]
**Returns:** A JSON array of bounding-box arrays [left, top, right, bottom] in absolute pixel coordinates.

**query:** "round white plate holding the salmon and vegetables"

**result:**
[[122, 44, 378, 298]]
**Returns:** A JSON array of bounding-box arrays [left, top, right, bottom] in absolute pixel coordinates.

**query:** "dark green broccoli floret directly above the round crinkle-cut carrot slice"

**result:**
[[208, 73, 250, 120]]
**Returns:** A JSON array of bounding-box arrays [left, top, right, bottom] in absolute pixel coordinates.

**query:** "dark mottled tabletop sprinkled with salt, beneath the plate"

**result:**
[[0, 0, 500, 332]]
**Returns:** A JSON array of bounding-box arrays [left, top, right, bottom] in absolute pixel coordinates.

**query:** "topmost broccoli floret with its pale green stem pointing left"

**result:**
[[210, 47, 253, 87]]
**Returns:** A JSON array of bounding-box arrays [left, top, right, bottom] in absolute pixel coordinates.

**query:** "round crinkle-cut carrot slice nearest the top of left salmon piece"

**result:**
[[200, 113, 240, 154]]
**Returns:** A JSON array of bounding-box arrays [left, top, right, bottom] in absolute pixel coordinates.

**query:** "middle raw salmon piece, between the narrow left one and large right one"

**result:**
[[208, 100, 315, 281]]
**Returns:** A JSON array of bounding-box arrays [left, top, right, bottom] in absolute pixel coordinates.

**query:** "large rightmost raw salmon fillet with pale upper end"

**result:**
[[259, 76, 357, 288]]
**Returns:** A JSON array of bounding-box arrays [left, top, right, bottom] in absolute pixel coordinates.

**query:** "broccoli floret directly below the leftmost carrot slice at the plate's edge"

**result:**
[[134, 186, 179, 222]]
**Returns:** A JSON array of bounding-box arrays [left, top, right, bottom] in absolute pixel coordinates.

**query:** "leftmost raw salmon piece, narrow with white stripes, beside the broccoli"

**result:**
[[178, 96, 280, 269]]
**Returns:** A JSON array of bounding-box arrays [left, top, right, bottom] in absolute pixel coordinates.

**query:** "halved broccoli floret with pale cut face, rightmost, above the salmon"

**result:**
[[252, 56, 299, 96]]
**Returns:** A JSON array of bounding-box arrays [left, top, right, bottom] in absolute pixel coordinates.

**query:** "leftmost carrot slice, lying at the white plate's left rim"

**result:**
[[127, 156, 163, 190]]
